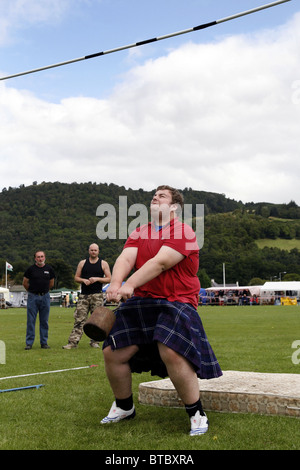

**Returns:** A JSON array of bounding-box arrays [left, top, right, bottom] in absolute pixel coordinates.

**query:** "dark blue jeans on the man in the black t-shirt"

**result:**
[[26, 292, 50, 346]]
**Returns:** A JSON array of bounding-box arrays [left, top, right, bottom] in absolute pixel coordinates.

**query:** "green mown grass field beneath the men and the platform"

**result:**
[[0, 306, 300, 451]]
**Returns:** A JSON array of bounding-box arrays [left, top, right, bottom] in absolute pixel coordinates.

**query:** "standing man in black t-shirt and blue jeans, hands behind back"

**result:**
[[23, 251, 55, 350]]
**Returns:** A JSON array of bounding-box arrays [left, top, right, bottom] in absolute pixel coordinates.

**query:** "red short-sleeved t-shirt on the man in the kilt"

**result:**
[[124, 219, 200, 308]]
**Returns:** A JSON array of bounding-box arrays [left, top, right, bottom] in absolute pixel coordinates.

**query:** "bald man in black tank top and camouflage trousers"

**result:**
[[63, 243, 111, 349]]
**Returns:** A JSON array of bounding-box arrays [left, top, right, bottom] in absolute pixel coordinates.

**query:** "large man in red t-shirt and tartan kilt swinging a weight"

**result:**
[[101, 186, 222, 436]]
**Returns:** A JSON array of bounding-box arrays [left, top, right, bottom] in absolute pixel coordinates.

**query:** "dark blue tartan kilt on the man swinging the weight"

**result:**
[[103, 297, 222, 379]]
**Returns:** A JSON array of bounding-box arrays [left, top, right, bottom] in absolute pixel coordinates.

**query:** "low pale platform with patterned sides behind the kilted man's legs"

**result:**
[[139, 371, 300, 418]]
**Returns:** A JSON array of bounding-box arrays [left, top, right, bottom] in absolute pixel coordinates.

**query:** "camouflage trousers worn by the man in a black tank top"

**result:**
[[68, 292, 103, 345]]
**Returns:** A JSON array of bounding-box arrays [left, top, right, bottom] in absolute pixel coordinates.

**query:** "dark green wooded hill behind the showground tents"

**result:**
[[0, 182, 300, 287]]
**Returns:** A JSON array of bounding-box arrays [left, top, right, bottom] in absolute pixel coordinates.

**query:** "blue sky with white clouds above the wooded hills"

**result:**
[[0, 0, 300, 205]]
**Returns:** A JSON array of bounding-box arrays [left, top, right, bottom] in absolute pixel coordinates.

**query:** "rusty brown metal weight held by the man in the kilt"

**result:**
[[83, 307, 117, 342]]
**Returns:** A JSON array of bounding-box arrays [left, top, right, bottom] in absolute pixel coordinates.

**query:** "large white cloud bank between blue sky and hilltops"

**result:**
[[0, 15, 300, 204]]
